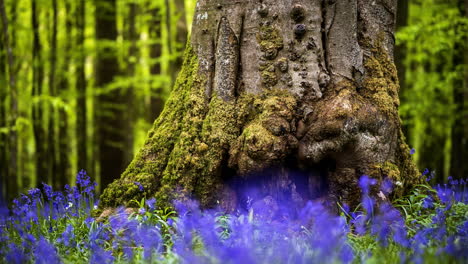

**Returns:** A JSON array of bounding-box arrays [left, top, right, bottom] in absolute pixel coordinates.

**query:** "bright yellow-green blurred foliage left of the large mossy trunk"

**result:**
[[0, 0, 195, 198]]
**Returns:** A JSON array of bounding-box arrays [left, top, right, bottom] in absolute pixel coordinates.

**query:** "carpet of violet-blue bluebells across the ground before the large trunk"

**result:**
[[0, 171, 468, 264]]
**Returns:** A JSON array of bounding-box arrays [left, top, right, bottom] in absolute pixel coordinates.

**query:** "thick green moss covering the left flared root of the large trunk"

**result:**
[[101, 45, 206, 206]]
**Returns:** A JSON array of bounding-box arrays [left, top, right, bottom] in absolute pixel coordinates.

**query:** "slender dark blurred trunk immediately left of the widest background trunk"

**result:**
[[75, 0, 87, 173]]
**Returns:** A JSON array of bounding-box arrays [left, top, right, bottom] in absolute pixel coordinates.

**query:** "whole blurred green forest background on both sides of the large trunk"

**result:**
[[0, 0, 468, 198]]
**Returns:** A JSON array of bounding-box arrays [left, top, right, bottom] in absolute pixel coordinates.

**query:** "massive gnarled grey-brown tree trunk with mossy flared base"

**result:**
[[101, 0, 418, 210]]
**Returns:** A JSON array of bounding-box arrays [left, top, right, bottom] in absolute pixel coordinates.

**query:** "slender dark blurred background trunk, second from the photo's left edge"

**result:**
[[31, 0, 49, 185]]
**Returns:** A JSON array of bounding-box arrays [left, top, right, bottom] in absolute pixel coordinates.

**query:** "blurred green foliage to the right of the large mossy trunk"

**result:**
[[397, 0, 468, 181]]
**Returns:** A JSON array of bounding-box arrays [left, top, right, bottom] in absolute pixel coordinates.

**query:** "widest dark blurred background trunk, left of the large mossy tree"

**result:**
[[95, 0, 128, 191]]
